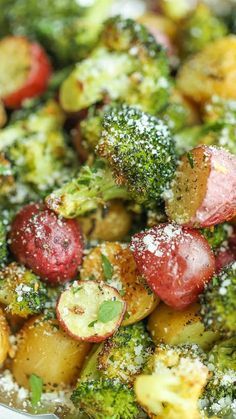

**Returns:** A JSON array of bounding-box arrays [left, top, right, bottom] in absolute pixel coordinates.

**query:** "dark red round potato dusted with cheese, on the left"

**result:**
[[9, 204, 83, 285]]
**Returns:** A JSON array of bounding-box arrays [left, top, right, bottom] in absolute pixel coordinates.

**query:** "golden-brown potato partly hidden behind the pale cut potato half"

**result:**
[[80, 242, 159, 326]]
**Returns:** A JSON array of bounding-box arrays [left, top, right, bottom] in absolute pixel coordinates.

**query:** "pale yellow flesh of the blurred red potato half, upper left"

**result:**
[[0, 37, 31, 98]]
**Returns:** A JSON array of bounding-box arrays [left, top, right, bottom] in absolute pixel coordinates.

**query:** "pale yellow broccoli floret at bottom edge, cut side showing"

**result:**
[[134, 345, 208, 419]]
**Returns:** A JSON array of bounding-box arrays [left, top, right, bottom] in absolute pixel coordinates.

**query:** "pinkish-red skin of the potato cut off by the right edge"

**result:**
[[187, 146, 236, 227]]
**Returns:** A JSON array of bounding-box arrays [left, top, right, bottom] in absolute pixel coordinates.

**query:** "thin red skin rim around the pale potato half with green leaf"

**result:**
[[56, 281, 127, 343]]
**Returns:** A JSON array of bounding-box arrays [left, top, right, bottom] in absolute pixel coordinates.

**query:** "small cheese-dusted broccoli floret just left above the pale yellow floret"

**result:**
[[98, 323, 153, 384]]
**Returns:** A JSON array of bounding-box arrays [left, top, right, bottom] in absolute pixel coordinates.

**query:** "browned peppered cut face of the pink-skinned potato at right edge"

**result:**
[[166, 147, 210, 224]]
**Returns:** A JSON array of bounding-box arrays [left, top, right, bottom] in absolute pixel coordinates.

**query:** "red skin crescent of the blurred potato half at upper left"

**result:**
[[3, 43, 52, 109]]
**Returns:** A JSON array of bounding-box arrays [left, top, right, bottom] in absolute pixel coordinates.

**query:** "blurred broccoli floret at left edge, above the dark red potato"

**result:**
[[0, 101, 74, 191]]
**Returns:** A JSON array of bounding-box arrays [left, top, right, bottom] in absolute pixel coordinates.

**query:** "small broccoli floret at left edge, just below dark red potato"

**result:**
[[0, 262, 48, 317]]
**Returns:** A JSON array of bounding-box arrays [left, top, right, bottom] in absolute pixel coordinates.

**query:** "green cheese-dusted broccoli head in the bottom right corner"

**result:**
[[199, 369, 236, 419]]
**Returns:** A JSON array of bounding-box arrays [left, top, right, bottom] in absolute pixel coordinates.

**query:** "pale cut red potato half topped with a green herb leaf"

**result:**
[[56, 281, 126, 343]]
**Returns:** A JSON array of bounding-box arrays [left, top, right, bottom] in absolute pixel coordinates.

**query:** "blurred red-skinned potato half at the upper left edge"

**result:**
[[0, 36, 52, 108]]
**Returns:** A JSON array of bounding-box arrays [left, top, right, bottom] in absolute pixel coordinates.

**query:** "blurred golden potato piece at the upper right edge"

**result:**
[[177, 35, 236, 104]]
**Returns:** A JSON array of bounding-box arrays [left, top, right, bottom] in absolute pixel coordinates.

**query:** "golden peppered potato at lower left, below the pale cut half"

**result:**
[[12, 316, 91, 390]]
